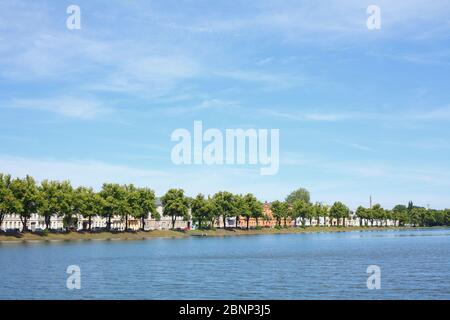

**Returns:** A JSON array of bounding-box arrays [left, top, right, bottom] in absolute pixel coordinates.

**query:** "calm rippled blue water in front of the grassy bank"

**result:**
[[0, 229, 450, 299]]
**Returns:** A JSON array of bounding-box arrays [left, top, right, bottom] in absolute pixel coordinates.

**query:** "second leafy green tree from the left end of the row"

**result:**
[[11, 175, 38, 232]]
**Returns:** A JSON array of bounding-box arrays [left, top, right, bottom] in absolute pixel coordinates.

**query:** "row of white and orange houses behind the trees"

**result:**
[[0, 201, 395, 231]]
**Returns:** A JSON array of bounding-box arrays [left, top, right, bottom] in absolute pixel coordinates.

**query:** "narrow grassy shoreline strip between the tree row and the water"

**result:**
[[0, 227, 445, 244]]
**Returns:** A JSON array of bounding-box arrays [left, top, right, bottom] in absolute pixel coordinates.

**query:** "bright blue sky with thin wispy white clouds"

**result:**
[[0, 0, 450, 209]]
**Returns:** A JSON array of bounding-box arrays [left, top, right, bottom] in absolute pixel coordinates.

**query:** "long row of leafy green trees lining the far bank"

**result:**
[[0, 174, 450, 231]]
